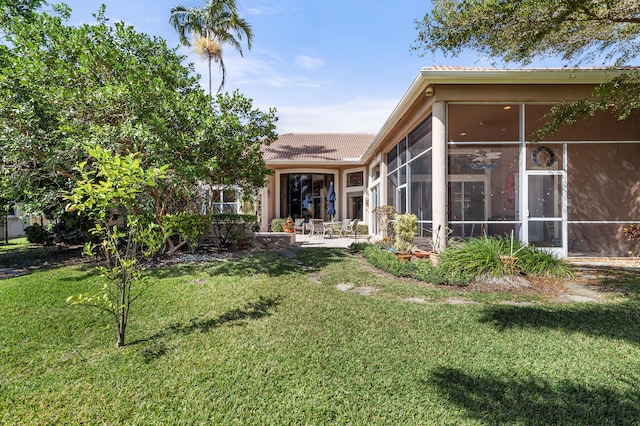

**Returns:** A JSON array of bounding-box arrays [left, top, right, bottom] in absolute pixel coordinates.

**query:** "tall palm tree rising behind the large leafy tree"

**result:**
[[169, 0, 253, 95]]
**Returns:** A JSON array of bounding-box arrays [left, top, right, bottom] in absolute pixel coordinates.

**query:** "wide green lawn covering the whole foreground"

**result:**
[[0, 249, 640, 425]]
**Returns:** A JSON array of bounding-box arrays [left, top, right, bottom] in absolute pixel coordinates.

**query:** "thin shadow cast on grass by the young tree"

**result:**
[[130, 296, 282, 363]]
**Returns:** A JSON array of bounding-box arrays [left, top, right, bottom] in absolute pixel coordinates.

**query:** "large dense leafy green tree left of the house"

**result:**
[[0, 5, 276, 223]]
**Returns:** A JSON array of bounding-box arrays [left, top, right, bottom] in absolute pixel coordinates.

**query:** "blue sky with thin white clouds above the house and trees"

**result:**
[[52, 0, 560, 133]]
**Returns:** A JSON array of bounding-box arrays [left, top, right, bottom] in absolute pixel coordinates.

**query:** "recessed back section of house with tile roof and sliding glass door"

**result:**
[[258, 133, 375, 227]]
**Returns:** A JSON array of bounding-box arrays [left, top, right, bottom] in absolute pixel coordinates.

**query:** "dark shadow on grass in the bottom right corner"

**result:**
[[425, 367, 640, 425]]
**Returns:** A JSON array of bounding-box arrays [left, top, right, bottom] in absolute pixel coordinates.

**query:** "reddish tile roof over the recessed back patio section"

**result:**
[[263, 133, 375, 164]]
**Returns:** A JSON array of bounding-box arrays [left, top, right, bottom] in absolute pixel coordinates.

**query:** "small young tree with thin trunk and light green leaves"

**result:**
[[67, 146, 167, 346]]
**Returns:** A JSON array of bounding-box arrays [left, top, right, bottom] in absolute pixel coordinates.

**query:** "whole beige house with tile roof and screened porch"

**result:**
[[257, 67, 640, 257]]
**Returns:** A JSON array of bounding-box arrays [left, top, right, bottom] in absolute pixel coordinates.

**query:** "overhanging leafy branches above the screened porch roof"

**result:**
[[414, 0, 640, 132]]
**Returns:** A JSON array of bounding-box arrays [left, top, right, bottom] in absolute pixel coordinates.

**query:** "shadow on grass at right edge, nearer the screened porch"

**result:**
[[480, 300, 640, 344]]
